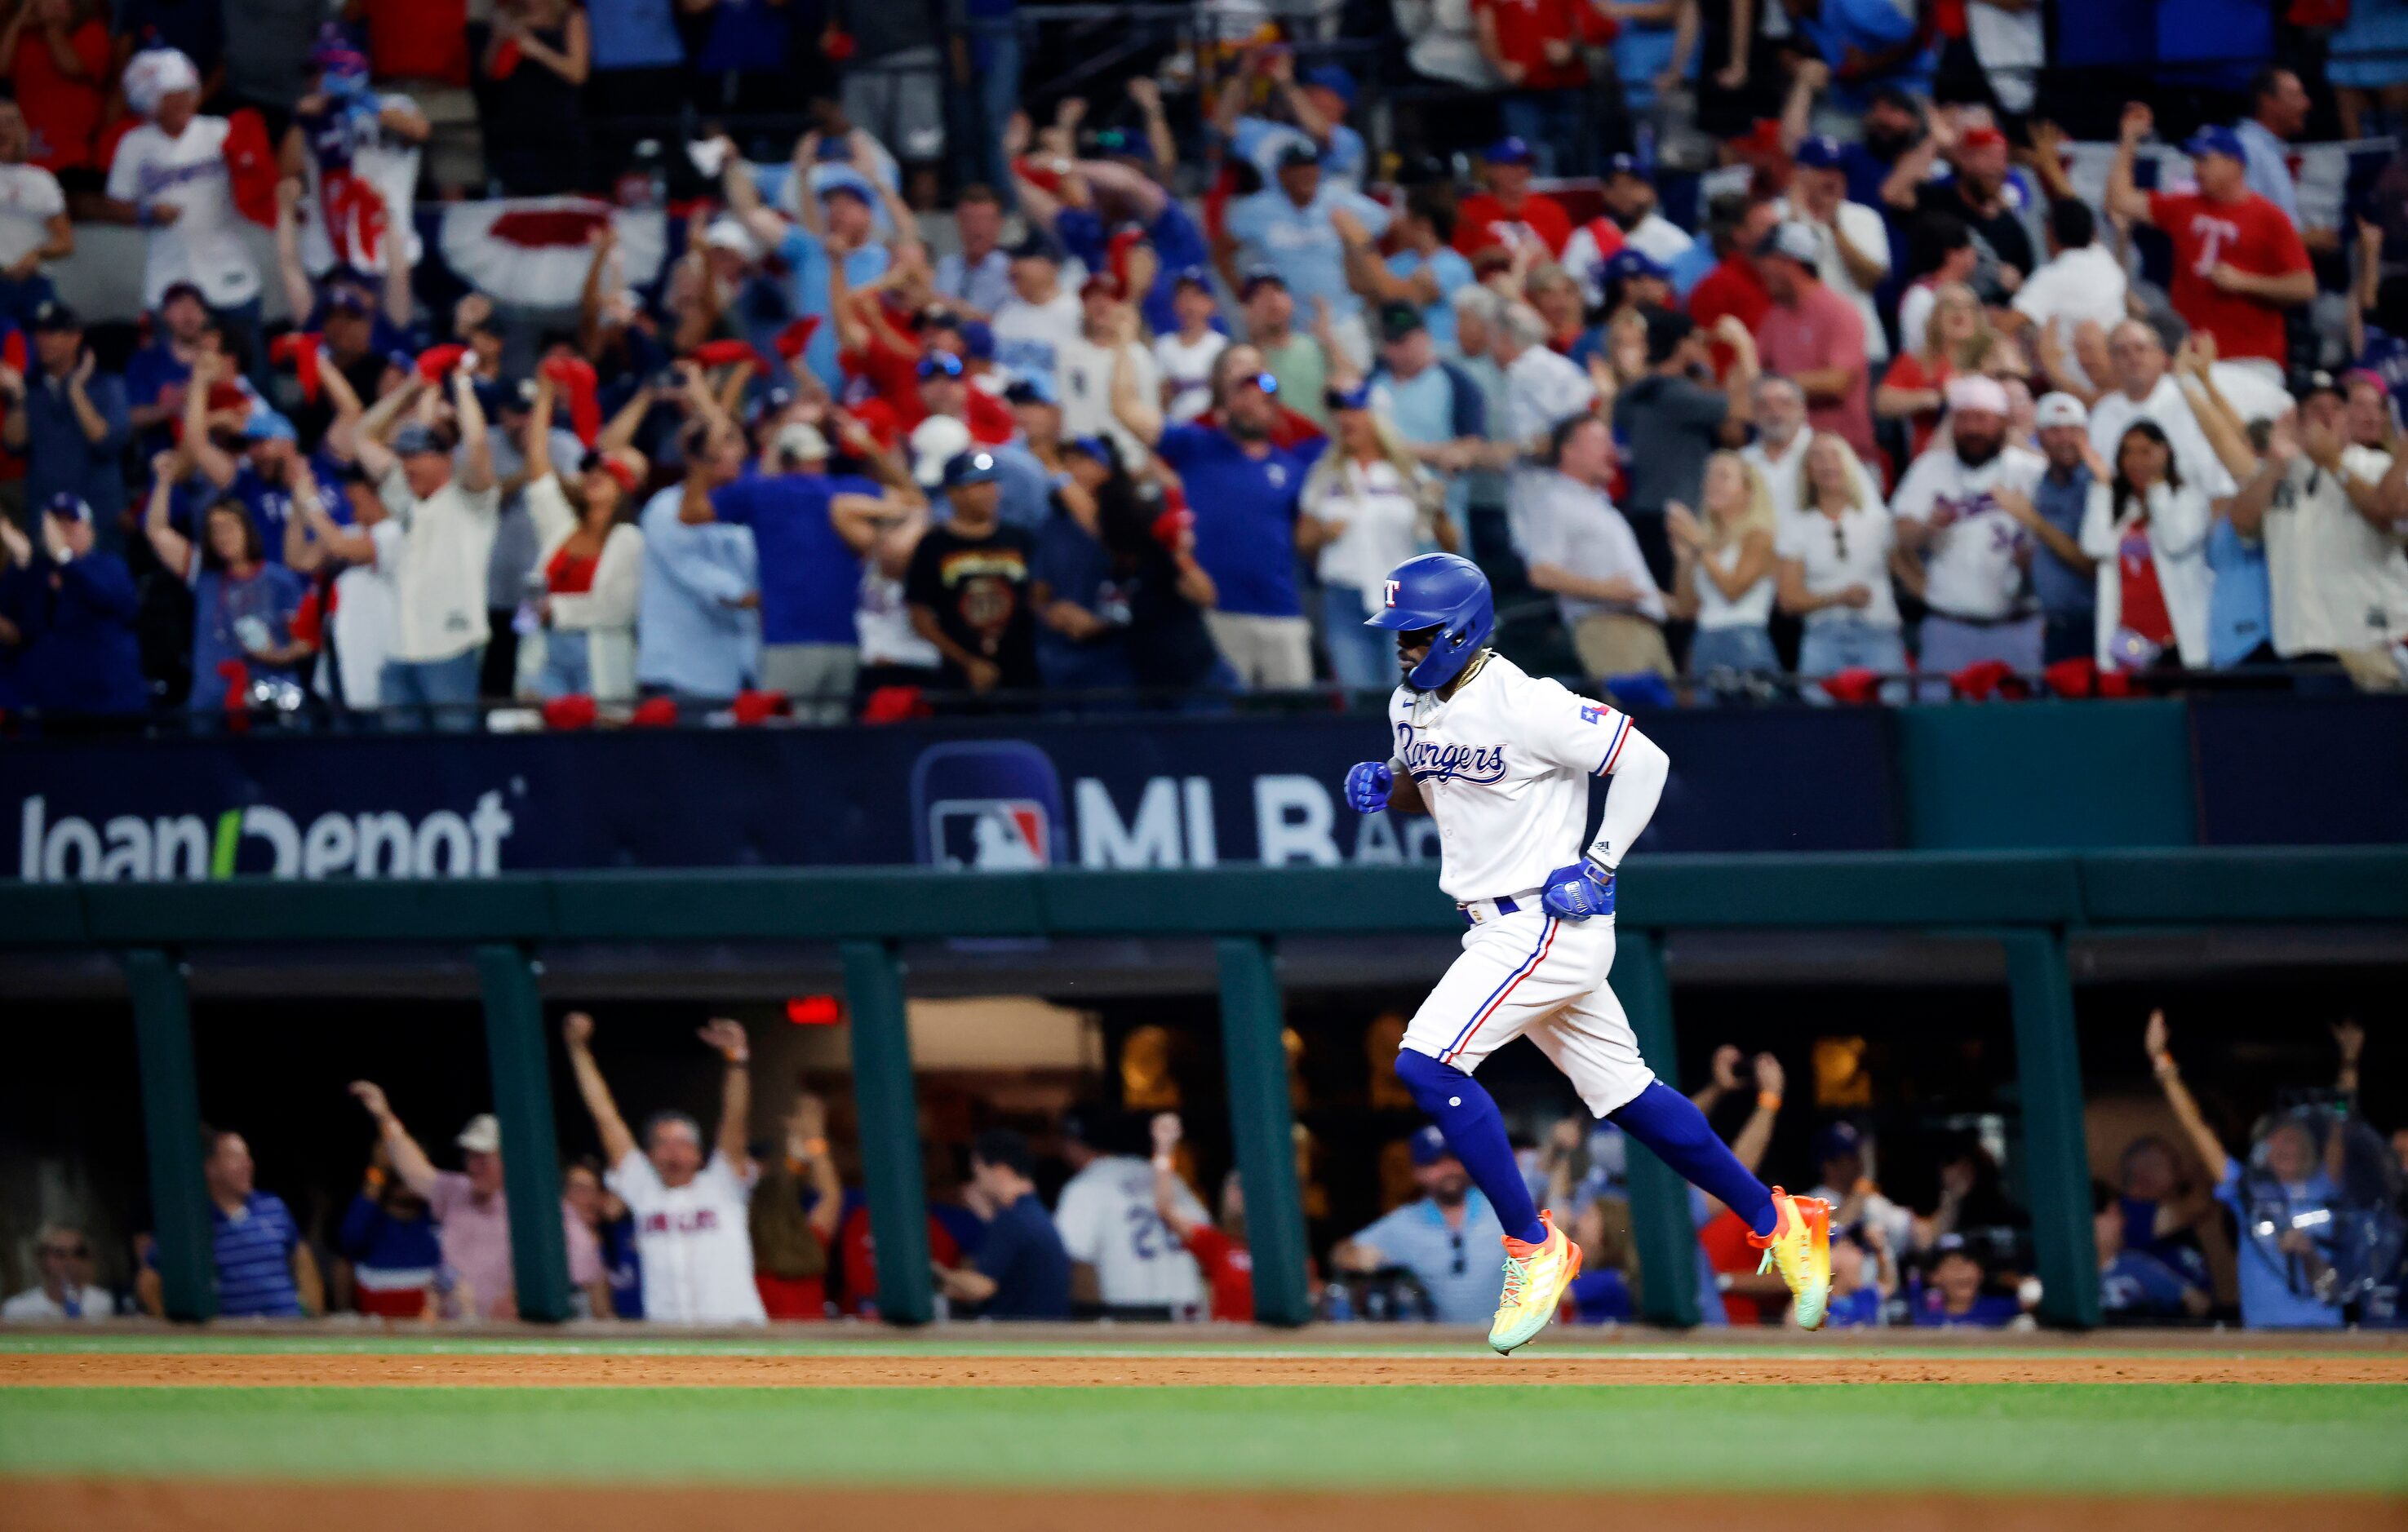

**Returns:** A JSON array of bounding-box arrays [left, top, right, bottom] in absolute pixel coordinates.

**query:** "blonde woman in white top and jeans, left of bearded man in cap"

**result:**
[[1772, 432, 1907, 701]]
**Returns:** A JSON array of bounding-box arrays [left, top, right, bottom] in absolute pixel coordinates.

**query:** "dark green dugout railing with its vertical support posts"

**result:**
[[0, 848, 2408, 1325]]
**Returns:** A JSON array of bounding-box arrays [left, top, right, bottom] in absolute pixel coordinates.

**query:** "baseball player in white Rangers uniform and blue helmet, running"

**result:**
[[1346, 554, 1830, 1352]]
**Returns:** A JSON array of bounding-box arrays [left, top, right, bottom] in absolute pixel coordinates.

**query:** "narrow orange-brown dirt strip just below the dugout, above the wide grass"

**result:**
[[0, 1349, 2408, 1388]]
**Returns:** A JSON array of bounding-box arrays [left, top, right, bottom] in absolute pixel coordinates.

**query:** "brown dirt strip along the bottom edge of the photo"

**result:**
[[0, 1479, 2408, 1532]]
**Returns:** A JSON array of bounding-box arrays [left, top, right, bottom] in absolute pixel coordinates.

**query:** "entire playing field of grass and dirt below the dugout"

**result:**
[[0, 1327, 2408, 1532]]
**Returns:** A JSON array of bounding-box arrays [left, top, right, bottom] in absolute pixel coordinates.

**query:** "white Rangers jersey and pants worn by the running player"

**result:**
[[1387, 653, 1669, 1118]]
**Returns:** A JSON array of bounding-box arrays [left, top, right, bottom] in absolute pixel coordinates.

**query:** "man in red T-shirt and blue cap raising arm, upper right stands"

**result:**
[[2107, 101, 2317, 370]]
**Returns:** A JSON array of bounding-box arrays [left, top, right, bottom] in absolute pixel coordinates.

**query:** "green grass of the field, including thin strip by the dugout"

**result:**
[[0, 1337, 2408, 1499]]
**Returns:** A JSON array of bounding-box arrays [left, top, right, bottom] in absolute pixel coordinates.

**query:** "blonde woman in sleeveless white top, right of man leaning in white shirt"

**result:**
[[1664, 453, 1782, 682]]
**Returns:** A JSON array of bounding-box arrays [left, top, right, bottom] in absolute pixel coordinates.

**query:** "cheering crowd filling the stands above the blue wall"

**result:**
[[0, 0, 2408, 728]]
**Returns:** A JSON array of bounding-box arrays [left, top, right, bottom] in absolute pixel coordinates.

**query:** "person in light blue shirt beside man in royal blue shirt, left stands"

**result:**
[[636, 422, 761, 698]]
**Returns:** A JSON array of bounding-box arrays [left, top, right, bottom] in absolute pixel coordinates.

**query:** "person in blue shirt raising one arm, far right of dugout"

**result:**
[[2143, 1012, 2340, 1330]]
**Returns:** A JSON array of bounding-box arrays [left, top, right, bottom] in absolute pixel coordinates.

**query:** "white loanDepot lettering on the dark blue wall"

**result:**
[[17, 792, 513, 884]]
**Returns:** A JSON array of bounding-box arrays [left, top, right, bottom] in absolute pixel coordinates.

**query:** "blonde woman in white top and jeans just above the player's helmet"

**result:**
[[1296, 385, 1461, 691]]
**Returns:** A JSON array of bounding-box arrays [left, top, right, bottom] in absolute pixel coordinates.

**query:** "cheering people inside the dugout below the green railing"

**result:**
[[14, 1012, 2408, 1330]]
